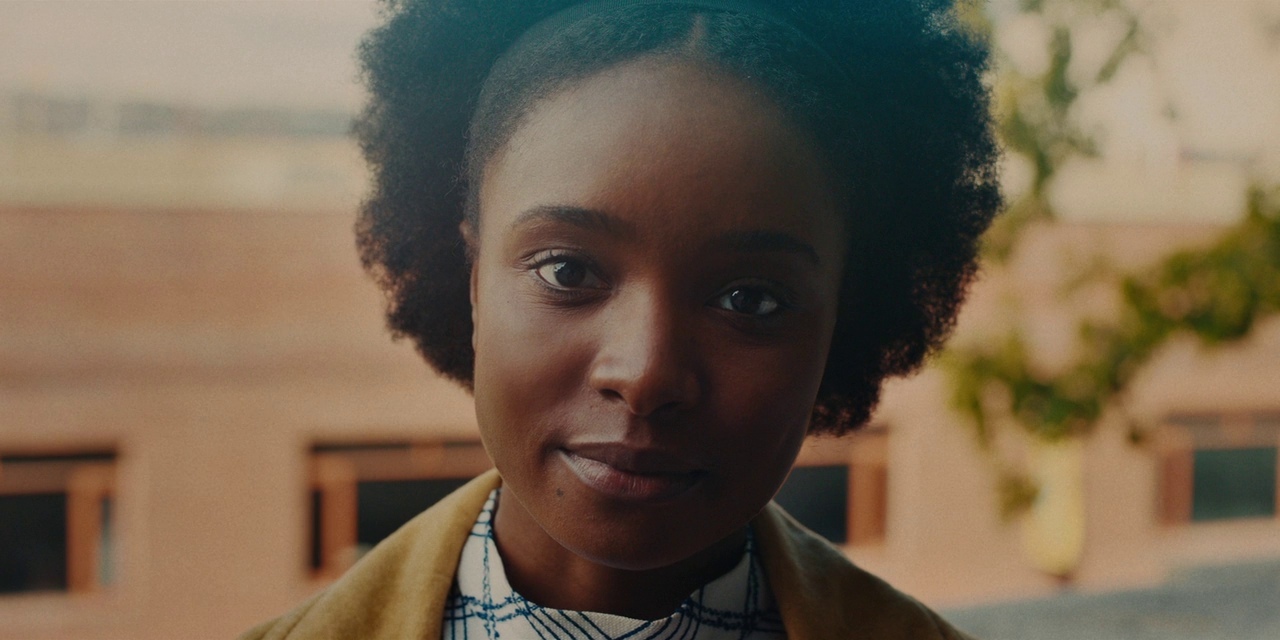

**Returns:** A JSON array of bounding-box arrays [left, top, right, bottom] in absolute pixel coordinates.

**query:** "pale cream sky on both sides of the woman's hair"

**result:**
[[0, 0, 1280, 218]]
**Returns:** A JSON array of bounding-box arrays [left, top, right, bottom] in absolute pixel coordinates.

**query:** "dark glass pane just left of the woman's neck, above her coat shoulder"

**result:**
[[356, 477, 471, 547]]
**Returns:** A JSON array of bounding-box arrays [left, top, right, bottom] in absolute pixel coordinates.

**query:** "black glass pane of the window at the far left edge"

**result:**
[[0, 493, 67, 593]]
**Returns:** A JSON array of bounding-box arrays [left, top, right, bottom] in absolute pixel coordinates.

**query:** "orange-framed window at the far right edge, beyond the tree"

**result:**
[[1158, 413, 1280, 524]]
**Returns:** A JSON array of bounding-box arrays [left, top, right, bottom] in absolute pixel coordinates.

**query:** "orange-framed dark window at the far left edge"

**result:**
[[0, 452, 115, 594]]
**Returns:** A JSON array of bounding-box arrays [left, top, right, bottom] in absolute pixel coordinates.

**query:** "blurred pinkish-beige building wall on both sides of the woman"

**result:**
[[0, 209, 1280, 639]]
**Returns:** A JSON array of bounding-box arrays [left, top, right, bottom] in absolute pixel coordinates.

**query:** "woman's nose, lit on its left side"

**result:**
[[589, 291, 703, 417]]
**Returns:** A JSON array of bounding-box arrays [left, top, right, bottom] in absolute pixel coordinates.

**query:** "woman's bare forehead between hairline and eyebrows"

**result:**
[[479, 58, 840, 252]]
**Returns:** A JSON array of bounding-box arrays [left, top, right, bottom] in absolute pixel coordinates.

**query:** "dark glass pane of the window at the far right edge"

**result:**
[[1192, 447, 1276, 520]]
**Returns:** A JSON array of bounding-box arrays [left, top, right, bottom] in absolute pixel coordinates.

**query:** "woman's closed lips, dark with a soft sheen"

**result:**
[[558, 443, 707, 502]]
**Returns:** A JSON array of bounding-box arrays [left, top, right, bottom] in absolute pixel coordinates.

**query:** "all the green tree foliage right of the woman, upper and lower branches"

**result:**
[[942, 0, 1280, 535]]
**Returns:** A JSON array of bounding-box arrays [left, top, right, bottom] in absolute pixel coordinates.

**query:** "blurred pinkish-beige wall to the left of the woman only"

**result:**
[[0, 210, 474, 637]]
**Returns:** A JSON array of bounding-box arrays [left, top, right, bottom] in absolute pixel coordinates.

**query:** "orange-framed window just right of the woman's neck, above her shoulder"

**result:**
[[774, 428, 888, 544]]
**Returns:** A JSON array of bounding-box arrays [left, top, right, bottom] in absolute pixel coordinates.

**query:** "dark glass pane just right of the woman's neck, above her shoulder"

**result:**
[[773, 465, 849, 544]]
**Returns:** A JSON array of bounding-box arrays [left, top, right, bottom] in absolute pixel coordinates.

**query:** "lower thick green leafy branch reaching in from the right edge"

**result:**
[[943, 187, 1280, 516]]
